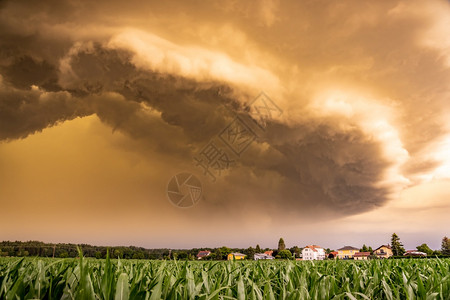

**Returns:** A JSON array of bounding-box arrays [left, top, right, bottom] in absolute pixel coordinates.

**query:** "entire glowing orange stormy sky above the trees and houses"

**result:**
[[0, 0, 450, 249]]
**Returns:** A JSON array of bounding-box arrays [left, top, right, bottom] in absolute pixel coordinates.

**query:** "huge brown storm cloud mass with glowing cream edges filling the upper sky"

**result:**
[[0, 1, 450, 246]]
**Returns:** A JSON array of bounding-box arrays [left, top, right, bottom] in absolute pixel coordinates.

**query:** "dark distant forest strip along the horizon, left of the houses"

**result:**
[[0, 241, 276, 260]]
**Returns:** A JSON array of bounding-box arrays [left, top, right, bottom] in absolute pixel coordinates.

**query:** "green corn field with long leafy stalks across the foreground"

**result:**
[[0, 256, 450, 300]]
